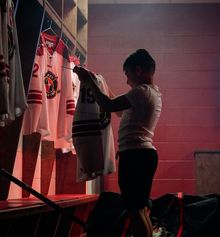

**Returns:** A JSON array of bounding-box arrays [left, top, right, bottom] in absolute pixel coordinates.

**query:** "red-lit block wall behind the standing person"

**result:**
[[88, 4, 220, 196]]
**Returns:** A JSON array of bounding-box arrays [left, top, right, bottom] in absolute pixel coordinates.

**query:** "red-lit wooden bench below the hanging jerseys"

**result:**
[[0, 194, 98, 237]]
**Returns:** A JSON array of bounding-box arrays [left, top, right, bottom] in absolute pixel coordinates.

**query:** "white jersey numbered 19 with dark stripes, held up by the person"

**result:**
[[73, 75, 116, 181]]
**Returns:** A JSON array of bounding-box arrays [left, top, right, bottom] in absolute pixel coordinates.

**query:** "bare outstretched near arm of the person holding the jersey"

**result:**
[[74, 67, 131, 112]]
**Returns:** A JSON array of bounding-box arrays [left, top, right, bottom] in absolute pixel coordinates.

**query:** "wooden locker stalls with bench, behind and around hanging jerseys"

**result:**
[[0, 0, 97, 236]]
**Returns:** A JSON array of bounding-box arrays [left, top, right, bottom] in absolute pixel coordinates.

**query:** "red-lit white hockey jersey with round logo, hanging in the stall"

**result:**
[[23, 33, 75, 148]]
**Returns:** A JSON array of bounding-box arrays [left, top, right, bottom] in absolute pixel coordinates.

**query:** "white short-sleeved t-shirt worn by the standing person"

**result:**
[[118, 84, 162, 151]]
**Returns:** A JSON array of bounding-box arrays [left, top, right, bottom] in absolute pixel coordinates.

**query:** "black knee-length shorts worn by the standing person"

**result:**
[[118, 149, 158, 210]]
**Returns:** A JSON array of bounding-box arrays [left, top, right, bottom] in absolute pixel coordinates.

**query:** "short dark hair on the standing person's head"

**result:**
[[123, 49, 156, 73]]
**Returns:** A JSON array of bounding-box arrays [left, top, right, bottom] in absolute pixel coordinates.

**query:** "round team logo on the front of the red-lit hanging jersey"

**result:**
[[44, 71, 58, 99]]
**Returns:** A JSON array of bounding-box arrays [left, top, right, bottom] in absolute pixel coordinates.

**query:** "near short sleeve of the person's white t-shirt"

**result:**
[[125, 85, 151, 107]]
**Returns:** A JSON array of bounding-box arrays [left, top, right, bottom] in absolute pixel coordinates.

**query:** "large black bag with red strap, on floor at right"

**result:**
[[151, 194, 220, 237]]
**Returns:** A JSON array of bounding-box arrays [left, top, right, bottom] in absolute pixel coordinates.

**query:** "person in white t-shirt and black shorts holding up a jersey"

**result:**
[[74, 49, 162, 237]]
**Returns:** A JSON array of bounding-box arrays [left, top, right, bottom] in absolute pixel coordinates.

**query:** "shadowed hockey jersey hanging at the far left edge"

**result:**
[[0, 0, 27, 126]]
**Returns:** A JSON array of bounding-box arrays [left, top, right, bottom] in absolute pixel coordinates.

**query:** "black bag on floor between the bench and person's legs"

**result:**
[[87, 192, 127, 237]]
